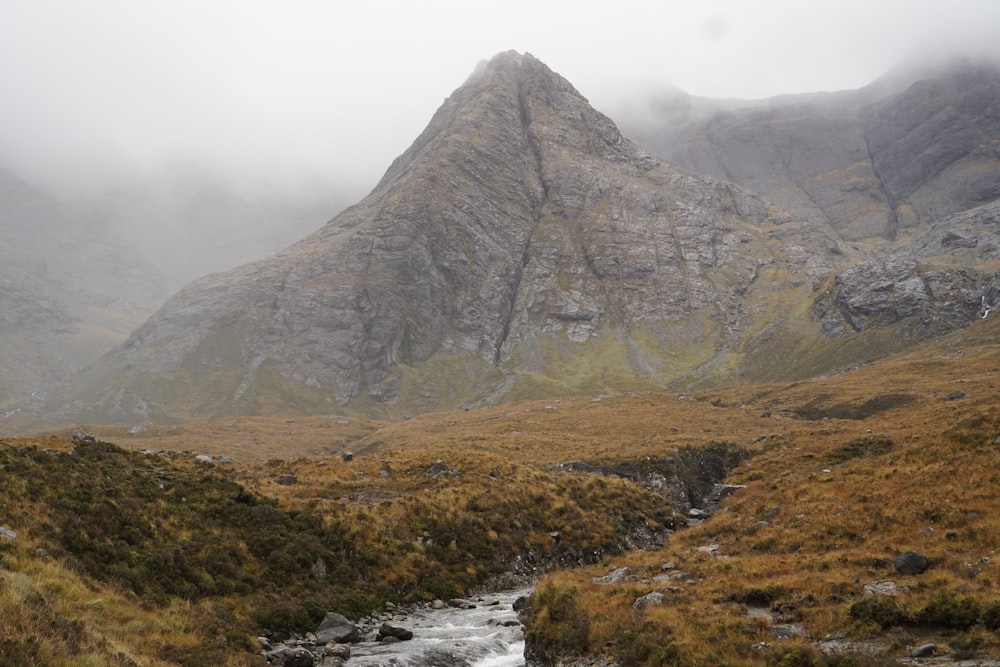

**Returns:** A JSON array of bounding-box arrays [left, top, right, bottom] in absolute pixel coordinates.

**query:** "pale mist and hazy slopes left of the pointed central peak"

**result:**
[[0, 163, 356, 410]]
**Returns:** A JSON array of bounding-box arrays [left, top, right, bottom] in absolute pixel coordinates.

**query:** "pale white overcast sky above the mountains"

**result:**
[[0, 0, 1000, 198]]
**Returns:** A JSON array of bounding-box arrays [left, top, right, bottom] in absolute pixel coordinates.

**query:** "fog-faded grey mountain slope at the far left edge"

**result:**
[[0, 169, 167, 414]]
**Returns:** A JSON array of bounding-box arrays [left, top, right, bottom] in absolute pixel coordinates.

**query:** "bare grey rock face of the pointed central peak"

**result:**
[[60, 53, 771, 419]]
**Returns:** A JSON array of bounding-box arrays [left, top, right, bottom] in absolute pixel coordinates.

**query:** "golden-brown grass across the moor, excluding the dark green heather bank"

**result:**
[[0, 320, 1000, 665]]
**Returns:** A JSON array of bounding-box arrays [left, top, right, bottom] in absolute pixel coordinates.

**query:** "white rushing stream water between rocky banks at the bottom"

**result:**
[[347, 589, 530, 667]]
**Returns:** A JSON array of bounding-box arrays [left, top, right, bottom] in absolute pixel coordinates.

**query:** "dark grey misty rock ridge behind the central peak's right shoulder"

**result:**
[[625, 56, 1000, 240]]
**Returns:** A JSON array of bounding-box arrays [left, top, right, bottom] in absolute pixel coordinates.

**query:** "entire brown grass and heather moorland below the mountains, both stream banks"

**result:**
[[0, 317, 1000, 665]]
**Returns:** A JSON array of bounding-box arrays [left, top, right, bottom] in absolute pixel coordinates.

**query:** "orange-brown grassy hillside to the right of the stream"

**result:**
[[526, 316, 1000, 665]]
